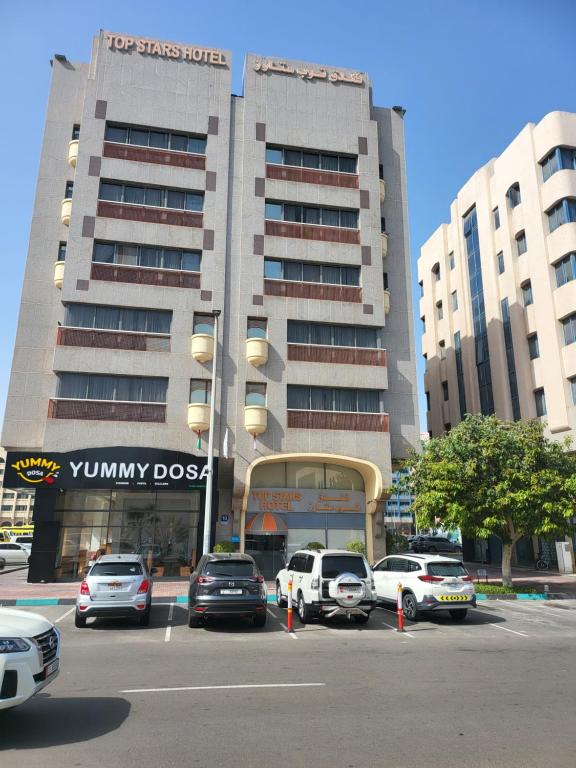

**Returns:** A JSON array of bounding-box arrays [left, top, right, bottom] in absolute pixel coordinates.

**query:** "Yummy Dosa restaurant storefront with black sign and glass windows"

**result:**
[[5, 447, 217, 582]]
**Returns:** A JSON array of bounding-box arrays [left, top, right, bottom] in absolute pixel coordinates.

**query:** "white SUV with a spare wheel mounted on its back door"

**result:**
[[276, 549, 376, 624]]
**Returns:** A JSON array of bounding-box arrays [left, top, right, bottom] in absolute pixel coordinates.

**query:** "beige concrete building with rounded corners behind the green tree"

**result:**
[[418, 112, 576, 439]]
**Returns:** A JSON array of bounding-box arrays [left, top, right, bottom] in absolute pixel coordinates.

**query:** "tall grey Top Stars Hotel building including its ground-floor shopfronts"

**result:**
[[2, 32, 418, 579]]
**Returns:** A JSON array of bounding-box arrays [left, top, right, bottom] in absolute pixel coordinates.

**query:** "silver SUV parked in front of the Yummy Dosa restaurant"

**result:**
[[75, 555, 153, 627]]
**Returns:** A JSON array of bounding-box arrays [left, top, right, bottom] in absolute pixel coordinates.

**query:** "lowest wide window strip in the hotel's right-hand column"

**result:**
[[288, 384, 382, 413]]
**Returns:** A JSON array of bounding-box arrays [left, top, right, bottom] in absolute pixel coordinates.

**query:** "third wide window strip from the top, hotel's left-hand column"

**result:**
[[92, 241, 202, 272]]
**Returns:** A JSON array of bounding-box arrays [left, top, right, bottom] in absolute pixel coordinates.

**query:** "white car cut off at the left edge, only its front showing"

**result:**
[[0, 608, 60, 710]]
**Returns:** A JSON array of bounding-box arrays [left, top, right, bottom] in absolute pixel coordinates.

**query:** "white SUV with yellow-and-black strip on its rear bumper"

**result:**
[[372, 554, 476, 621]]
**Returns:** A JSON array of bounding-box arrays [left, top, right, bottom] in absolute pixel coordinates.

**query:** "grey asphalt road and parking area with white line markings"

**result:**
[[0, 600, 576, 768]]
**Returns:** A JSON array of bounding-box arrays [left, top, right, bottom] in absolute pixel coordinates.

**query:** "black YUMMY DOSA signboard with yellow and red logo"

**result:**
[[4, 447, 212, 490]]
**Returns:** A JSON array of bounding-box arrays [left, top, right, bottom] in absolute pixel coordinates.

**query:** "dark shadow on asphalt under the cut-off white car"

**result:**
[[0, 693, 130, 749]]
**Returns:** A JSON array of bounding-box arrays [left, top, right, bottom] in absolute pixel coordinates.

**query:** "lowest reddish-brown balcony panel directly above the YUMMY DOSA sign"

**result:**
[[48, 398, 166, 424]]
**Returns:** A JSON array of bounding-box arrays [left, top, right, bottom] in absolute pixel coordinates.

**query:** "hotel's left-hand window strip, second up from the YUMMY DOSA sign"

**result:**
[[64, 304, 172, 333]]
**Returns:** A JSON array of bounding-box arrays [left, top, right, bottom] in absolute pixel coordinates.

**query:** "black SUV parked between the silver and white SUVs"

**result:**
[[188, 554, 267, 627]]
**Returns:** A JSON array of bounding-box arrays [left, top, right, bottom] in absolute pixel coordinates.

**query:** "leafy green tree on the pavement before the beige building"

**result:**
[[404, 415, 576, 586]]
